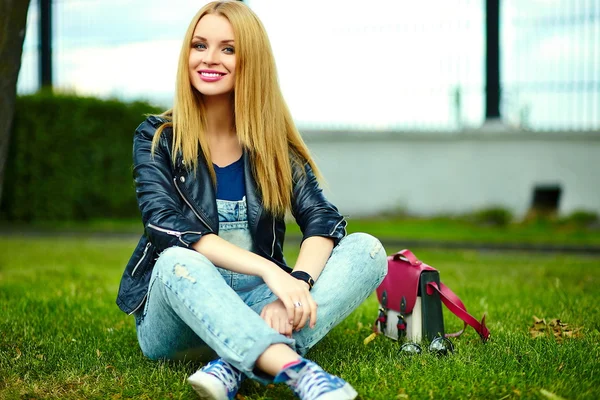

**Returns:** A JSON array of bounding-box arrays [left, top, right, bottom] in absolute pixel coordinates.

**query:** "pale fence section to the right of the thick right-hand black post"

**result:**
[[501, 0, 600, 130]]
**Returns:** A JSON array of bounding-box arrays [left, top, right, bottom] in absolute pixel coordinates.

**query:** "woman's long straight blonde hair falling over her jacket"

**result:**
[[152, 1, 320, 216]]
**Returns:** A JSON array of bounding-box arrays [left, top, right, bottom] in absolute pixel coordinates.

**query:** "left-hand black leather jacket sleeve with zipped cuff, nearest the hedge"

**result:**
[[133, 117, 211, 253]]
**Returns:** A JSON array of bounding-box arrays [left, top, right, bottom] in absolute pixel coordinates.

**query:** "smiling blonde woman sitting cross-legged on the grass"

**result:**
[[117, 1, 387, 400]]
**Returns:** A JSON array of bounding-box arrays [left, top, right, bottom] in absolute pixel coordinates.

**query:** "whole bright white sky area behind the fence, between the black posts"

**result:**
[[18, 0, 600, 132]]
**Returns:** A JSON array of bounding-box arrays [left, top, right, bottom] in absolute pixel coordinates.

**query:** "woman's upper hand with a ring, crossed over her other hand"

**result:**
[[261, 266, 317, 332]]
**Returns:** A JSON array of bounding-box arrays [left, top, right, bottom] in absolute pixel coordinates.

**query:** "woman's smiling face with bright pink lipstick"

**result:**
[[189, 14, 236, 96]]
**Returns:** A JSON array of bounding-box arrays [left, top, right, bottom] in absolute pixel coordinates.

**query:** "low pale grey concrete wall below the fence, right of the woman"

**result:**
[[302, 127, 600, 217]]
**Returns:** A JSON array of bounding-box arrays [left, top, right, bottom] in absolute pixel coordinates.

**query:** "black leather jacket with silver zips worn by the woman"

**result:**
[[117, 116, 346, 314]]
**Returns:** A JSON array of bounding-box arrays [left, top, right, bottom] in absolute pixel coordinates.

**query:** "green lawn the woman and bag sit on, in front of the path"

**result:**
[[0, 237, 600, 400]]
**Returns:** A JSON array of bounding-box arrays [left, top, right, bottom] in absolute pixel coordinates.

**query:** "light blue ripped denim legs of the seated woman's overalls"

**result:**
[[135, 233, 387, 382]]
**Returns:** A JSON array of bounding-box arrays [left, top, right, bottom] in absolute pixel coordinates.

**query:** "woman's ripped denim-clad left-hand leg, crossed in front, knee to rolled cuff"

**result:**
[[136, 247, 294, 377]]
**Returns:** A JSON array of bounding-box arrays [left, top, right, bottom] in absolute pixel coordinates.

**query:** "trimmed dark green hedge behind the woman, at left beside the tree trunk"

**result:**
[[0, 93, 160, 221]]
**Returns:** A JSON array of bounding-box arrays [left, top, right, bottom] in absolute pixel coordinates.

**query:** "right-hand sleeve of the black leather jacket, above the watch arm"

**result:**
[[292, 159, 346, 246]]
